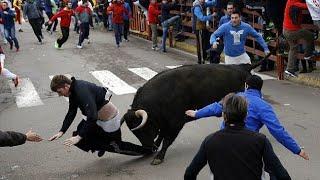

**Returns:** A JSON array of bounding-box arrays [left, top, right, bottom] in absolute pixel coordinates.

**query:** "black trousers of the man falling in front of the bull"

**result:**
[[73, 120, 152, 156]]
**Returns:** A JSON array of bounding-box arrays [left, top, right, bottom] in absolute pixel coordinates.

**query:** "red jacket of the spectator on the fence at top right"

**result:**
[[283, 0, 308, 31]]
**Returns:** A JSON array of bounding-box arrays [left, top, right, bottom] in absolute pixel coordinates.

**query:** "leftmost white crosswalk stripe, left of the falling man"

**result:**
[[10, 78, 43, 108]]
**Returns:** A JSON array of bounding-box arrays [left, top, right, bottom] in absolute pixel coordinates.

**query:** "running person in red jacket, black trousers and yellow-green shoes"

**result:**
[[48, 3, 74, 49]]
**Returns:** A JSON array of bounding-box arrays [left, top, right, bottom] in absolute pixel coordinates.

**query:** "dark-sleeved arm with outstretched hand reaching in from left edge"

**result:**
[[0, 130, 42, 147]]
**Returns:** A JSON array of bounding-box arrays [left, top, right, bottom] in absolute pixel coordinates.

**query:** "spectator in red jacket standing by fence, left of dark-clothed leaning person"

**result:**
[[148, 0, 161, 50]]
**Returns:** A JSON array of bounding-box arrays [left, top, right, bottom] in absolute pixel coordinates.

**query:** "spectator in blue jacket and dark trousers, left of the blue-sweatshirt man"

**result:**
[[191, 0, 216, 64]]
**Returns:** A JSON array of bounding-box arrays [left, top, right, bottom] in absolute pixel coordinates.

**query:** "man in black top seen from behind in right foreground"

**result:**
[[184, 94, 291, 180]]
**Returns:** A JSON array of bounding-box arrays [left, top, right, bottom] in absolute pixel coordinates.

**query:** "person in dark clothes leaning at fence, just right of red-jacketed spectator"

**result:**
[[161, 0, 180, 52]]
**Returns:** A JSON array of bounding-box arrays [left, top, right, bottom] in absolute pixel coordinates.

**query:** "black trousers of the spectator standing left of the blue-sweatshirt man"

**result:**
[[196, 29, 210, 64]]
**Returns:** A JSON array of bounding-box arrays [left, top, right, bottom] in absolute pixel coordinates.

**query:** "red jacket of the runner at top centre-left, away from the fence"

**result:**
[[107, 3, 129, 24]]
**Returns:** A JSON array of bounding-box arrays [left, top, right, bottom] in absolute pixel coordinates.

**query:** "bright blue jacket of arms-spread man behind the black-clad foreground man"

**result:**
[[196, 89, 301, 154]]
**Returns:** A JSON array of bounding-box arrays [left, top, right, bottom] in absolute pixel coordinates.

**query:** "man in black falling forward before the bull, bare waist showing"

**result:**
[[49, 75, 151, 157]]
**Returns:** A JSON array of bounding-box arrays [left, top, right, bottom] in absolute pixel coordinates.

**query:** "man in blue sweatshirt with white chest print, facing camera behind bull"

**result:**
[[210, 11, 270, 64]]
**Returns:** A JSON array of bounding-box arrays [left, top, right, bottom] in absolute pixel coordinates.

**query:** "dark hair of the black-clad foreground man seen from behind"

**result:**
[[223, 93, 248, 124]]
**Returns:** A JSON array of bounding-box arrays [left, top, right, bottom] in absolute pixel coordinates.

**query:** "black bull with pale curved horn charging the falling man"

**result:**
[[122, 63, 260, 165]]
